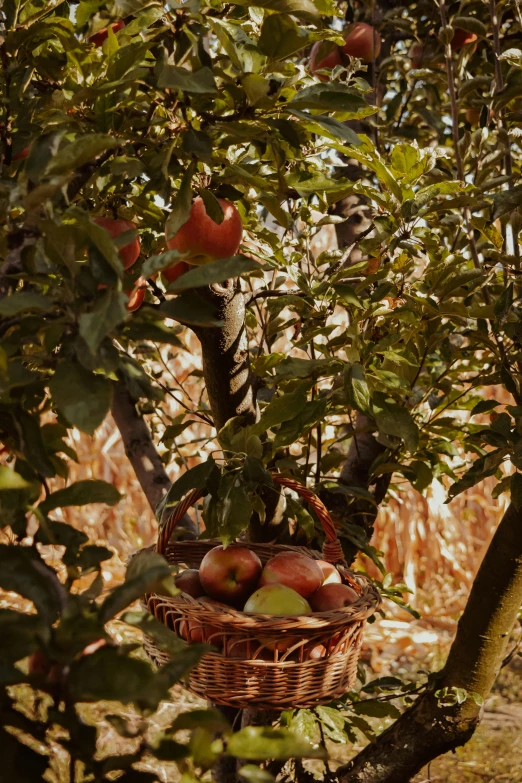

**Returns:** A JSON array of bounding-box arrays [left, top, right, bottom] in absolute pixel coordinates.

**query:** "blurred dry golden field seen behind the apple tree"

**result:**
[[0, 227, 522, 783]]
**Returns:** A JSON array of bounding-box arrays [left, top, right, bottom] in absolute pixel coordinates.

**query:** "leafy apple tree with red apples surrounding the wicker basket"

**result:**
[[0, 0, 522, 783]]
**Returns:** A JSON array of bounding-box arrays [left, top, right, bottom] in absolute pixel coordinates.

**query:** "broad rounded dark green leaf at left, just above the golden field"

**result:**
[[49, 360, 112, 435]]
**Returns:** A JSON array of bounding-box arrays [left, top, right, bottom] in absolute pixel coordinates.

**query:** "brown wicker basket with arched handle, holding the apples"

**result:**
[[144, 475, 380, 710]]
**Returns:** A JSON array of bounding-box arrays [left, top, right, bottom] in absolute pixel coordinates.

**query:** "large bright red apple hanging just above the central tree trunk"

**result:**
[[166, 196, 243, 266]]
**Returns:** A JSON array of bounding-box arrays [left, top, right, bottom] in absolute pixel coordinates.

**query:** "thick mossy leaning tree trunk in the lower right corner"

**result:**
[[337, 505, 522, 783]]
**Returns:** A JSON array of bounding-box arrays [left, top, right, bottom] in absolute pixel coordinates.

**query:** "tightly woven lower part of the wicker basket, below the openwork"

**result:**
[[144, 626, 362, 711]]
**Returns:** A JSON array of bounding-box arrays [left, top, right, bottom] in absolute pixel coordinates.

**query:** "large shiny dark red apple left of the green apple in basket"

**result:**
[[199, 544, 263, 606]]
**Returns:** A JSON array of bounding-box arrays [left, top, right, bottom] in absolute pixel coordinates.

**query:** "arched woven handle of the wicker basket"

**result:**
[[156, 473, 346, 565]]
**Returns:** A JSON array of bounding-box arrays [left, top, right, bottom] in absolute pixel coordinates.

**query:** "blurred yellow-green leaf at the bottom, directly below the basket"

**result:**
[[227, 726, 326, 761]]
